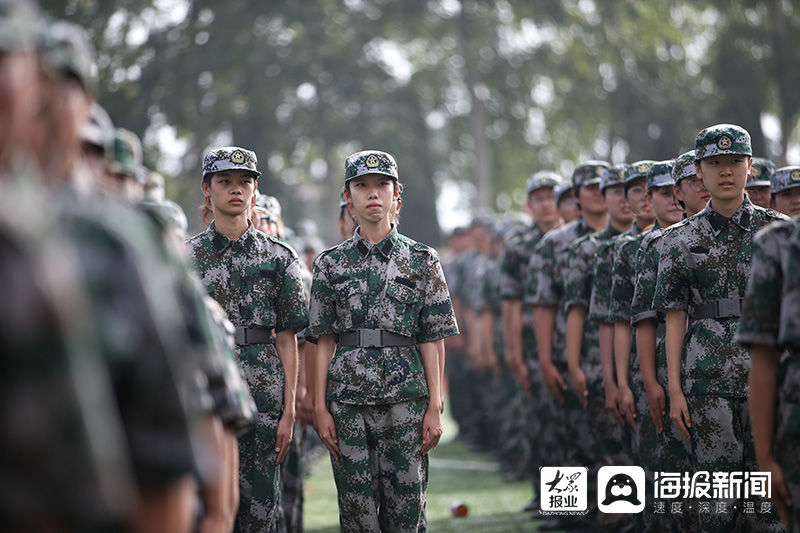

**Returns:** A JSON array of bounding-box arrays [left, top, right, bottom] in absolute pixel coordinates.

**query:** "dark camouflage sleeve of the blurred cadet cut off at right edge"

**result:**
[[736, 227, 783, 346]]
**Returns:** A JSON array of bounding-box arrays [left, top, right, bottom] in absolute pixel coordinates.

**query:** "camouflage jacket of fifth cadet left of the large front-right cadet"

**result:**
[[523, 218, 592, 367]]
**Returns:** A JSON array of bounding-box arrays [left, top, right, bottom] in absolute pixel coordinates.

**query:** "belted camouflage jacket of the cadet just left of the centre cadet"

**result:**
[[187, 222, 308, 416]]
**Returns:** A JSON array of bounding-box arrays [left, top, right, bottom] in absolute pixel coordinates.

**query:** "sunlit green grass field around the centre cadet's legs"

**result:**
[[303, 402, 536, 533]]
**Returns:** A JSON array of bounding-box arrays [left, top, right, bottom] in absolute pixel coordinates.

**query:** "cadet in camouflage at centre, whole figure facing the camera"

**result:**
[[309, 150, 458, 531]]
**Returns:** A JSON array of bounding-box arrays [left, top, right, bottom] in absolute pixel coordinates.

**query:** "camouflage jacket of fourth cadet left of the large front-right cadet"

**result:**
[[564, 224, 620, 376]]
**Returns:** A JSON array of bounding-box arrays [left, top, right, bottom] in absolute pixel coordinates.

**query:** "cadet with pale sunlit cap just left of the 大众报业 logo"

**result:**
[[500, 171, 563, 512]]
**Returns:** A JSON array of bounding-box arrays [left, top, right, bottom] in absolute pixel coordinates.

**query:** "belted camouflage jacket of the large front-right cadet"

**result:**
[[653, 197, 786, 398]]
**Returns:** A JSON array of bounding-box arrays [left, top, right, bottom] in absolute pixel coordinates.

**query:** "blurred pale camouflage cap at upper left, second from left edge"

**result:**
[[41, 21, 97, 92]]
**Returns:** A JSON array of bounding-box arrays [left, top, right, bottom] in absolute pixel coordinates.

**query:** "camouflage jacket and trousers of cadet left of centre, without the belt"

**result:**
[[187, 222, 308, 531]]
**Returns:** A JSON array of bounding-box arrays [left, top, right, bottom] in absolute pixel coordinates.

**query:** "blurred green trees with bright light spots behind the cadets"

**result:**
[[41, 0, 800, 244]]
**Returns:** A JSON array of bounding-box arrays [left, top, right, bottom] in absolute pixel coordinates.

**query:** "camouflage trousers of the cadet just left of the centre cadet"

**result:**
[[234, 413, 283, 533]]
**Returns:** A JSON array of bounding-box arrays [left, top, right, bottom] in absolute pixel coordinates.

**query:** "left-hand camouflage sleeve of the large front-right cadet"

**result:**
[[653, 230, 690, 312]]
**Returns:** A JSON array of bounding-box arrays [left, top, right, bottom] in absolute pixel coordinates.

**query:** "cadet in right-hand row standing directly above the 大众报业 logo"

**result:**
[[523, 161, 608, 526]]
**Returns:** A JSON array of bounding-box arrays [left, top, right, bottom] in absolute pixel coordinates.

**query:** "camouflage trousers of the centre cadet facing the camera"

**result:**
[[329, 397, 428, 532]]
